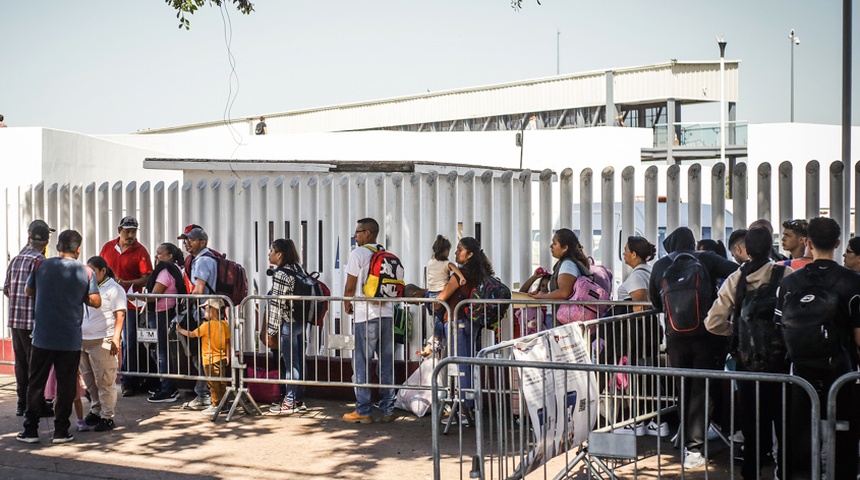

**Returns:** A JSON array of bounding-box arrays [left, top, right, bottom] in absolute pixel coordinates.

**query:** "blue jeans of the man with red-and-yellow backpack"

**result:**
[[352, 317, 394, 415]]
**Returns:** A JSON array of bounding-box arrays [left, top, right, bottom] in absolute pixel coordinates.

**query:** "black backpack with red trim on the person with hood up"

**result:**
[[660, 252, 716, 337]]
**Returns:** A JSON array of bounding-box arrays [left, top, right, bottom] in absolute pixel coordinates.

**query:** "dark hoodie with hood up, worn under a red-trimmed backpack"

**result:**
[[648, 227, 738, 312]]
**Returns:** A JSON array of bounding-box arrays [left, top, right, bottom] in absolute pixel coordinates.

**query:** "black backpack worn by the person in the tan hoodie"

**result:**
[[732, 265, 788, 373]]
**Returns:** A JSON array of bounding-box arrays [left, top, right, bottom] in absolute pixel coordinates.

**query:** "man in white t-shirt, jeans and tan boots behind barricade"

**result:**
[[343, 218, 394, 423]]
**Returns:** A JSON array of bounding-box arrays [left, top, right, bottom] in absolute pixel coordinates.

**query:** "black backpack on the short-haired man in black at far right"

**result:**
[[780, 269, 851, 371]]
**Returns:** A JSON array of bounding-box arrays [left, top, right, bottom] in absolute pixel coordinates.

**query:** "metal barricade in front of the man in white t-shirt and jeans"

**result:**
[[232, 295, 452, 410]]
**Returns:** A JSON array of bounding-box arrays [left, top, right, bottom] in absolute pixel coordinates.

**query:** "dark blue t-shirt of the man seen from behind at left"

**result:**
[[27, 257, 99, 351]]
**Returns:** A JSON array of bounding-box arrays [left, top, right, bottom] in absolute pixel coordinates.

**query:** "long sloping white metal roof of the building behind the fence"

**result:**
[[139, 61, 739, 134]]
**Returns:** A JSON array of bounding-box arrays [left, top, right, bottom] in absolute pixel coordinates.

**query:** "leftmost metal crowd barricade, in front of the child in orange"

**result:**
[[118, 293, 247, 421]]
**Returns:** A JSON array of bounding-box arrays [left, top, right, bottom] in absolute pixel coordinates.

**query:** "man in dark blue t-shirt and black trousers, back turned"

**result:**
[[16, 230, 102, 443]]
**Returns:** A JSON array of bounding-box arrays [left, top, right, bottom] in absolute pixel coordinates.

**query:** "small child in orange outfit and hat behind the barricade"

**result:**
[[176, 298, 230, 415]]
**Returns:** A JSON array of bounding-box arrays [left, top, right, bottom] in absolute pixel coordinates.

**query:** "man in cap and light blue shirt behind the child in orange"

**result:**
[[176, 224, 218, 410]]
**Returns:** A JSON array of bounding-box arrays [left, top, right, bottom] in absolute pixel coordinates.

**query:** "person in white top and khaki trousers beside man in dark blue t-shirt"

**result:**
[[81, 257, 127, 432]]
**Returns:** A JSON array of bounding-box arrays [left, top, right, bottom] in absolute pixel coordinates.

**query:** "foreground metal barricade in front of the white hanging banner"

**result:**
[[432, 354, 833, 479]]
